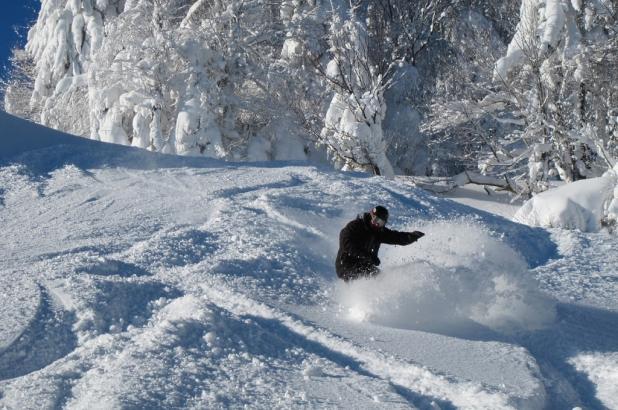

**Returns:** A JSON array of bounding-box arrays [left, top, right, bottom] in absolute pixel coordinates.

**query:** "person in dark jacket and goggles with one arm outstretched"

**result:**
[[335, 206, 425, 282]]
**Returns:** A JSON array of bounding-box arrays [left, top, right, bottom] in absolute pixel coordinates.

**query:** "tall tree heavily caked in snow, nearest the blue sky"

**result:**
[[26, 0, 124, 135]]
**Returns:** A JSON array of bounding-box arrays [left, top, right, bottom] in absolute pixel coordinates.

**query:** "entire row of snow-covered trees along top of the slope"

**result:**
[[4, 0, 618, 194]]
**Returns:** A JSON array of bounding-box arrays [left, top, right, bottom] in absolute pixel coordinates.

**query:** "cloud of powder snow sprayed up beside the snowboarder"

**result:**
[[337, 221, 555, 334]]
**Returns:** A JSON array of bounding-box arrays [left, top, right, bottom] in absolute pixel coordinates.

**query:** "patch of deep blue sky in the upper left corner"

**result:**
[[0, 0, 41, 75]]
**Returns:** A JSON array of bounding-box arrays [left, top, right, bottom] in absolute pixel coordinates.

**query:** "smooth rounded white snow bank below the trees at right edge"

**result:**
[[514, 171, 618, 232]]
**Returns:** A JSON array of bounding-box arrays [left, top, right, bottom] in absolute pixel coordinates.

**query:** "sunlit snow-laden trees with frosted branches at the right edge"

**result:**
[[428, 0, 618, 193]]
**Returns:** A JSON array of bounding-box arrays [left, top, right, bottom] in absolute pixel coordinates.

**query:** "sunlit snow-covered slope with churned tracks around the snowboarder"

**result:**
[[0, 112, 618, 409]]
